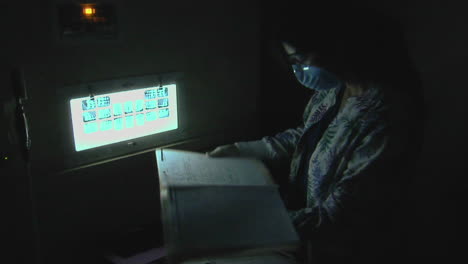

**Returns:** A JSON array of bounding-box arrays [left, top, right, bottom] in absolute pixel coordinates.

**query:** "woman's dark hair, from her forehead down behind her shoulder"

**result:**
[[262, 0, 425, 160]]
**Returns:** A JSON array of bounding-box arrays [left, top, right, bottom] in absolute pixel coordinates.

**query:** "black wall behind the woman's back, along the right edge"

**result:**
[[344, 0, 468, 256]]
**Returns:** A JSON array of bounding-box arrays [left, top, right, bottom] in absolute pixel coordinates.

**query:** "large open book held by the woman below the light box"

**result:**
[[156, 149, 299, 262]]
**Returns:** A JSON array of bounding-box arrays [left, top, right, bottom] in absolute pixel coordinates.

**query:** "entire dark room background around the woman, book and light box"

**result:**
[[0, 0, 468, 263]]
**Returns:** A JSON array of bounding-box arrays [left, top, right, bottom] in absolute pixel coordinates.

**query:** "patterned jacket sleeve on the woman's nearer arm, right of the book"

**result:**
[[290, 126, 388, 236]]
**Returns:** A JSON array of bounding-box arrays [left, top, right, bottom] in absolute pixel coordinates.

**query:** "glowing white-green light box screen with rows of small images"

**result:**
[[70, 84, 178, 151]]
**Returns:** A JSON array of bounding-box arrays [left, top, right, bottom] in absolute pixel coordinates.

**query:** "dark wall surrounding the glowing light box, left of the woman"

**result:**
[[0, 0, 259, 263]]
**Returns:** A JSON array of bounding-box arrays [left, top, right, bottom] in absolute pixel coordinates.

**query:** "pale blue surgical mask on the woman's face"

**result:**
[[292, 64, 341, 91]]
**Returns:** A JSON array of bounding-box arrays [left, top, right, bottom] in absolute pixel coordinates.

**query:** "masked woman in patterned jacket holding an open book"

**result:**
[[208, 2, 416, 262]]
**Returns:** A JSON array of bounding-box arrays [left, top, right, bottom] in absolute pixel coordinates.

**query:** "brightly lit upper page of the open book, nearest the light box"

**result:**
[[156, 149, 273, 186]]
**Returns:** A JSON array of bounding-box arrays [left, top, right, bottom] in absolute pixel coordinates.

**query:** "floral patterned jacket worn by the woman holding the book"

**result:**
[[235, 85, 388, 236]]
